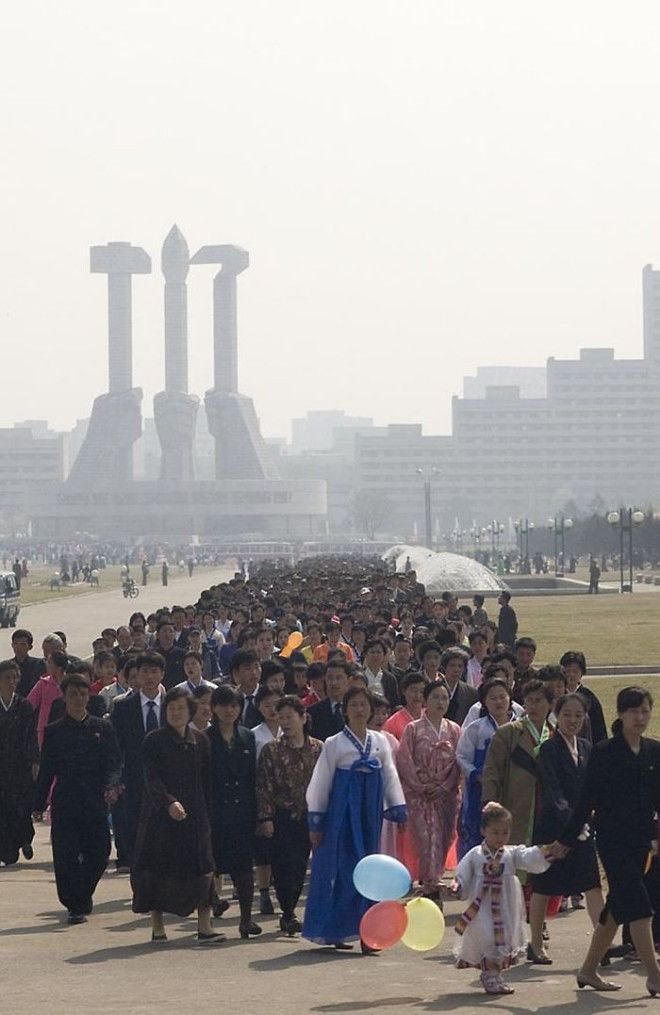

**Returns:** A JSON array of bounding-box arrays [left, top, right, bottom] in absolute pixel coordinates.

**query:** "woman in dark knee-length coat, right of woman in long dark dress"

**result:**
[[206, 684, 261, 938]]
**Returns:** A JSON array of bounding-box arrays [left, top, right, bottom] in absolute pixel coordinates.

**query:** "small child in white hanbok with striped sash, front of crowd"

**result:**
[[451, 803, 550, 994]]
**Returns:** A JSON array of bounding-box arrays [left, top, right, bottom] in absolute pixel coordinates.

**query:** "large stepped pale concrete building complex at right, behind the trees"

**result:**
[[355, 265, 660, 535]]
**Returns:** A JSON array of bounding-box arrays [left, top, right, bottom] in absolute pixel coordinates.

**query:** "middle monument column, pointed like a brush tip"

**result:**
[[153, 225, 199, 482]]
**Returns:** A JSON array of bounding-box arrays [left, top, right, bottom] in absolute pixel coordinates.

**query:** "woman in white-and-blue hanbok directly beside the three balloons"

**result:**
[[303, 687, 405, 948]]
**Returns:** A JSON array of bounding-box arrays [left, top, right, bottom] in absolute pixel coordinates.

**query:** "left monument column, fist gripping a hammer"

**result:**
[[67, 243, 151, 490]]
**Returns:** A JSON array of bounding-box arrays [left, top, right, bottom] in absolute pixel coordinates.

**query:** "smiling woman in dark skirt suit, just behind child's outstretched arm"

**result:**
[[527, 694, 603, 965]]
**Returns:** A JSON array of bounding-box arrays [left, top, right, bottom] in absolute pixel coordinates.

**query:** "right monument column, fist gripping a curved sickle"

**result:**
[[190, 244, 279, 480]]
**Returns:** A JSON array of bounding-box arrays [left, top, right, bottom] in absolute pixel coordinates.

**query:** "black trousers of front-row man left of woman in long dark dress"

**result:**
[[51, 811, 110, 915]]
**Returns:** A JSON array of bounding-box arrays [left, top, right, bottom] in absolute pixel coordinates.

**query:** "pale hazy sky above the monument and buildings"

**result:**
[[0, 0, 660, 435]]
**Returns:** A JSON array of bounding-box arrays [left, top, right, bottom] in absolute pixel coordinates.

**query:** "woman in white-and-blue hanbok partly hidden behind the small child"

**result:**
[[456, 677, 513, 860]]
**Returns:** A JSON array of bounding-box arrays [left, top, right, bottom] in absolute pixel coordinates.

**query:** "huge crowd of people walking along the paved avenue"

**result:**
[[0, 558, 660, 994]]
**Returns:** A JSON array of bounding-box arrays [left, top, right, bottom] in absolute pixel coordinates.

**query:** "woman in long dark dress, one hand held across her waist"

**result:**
[[131, 687, 224, 944]]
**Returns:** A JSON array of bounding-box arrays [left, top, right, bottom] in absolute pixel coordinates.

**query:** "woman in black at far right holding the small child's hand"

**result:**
[[553, 687, 660, 997]]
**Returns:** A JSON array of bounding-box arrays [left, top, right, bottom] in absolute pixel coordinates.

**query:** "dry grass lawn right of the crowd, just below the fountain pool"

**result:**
[[513, 592, 660, 672]]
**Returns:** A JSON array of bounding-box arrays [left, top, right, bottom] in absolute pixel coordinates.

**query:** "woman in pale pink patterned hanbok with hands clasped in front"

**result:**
[[396, 680, 461, 901]]
